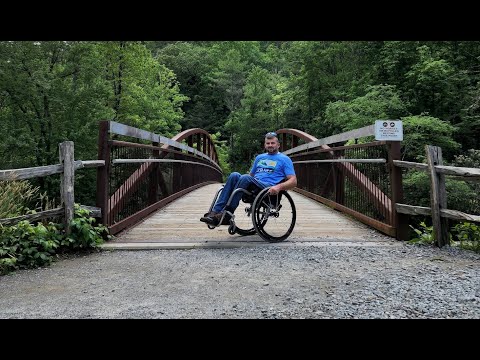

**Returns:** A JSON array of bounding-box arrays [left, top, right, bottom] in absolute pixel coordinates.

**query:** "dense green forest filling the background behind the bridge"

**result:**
[[0, 41, 480, 213]]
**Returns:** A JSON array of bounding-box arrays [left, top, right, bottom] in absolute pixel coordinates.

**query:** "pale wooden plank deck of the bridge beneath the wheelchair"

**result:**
[[103, 184, 400, 250]]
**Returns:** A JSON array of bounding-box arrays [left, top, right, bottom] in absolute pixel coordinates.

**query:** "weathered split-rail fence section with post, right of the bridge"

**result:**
[[393, 145, 480, 247]]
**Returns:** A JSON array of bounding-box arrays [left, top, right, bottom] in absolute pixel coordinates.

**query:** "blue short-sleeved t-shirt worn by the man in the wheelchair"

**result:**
[[250, 153, 295, 186]]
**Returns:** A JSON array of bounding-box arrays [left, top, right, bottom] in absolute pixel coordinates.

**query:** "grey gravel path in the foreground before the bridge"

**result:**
[[0, 243, 480, 319]]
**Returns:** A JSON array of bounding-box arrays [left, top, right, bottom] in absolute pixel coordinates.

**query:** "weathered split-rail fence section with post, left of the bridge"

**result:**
[[0, 141, 105, 234]]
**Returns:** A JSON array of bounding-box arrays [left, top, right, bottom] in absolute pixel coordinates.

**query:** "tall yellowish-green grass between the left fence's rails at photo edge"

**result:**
[[0, 180, 39, 218]]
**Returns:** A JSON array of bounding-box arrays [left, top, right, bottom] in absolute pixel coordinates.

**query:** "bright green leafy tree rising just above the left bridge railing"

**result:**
[[101, 41, 188, 137]]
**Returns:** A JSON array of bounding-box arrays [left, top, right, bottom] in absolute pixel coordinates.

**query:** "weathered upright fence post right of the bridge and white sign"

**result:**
[[425, 145, 450, 247]]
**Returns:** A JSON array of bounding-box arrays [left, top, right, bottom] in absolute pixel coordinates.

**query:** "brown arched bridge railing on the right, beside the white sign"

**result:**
[[277, 125, 408, 239]]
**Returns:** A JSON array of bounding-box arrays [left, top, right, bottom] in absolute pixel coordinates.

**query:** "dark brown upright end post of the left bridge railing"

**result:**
[[97, 120, 110, 226]]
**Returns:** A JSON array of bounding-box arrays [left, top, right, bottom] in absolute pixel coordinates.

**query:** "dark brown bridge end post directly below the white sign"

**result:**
[[388, 141, 409, 240]]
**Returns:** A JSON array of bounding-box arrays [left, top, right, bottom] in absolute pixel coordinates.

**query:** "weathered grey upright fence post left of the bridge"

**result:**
[[59, 141, 75, 235]]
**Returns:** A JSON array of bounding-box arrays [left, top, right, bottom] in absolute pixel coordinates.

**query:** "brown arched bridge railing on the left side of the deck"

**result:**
[[97, 121, 222, 234]]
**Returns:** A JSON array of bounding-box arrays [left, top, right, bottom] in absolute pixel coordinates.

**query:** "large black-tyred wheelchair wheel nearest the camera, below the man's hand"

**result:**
[[252, 188, 297, 242]]
